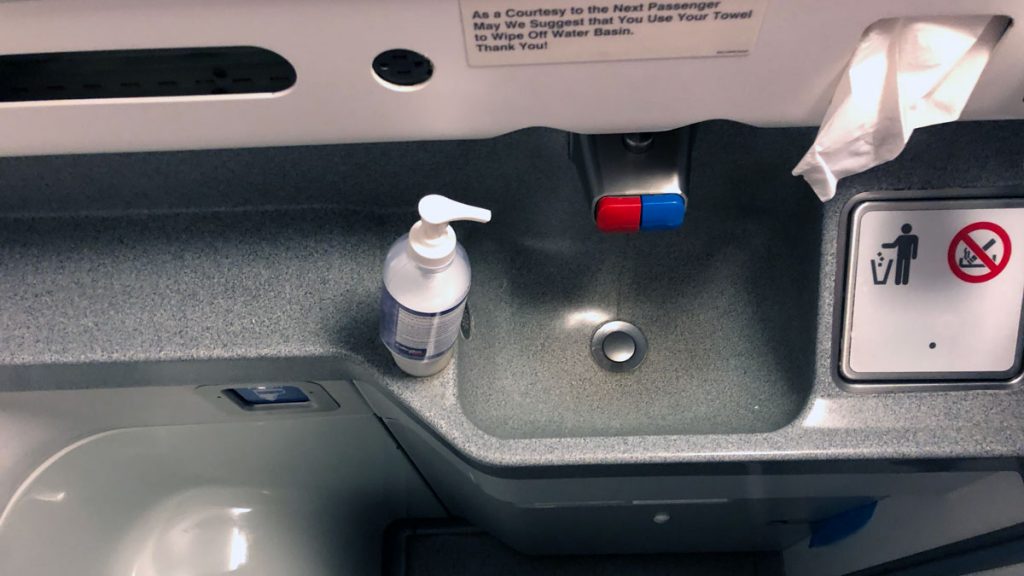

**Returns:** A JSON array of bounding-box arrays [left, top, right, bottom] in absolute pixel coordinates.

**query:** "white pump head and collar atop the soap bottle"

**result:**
[[409, 194, 490, 268]]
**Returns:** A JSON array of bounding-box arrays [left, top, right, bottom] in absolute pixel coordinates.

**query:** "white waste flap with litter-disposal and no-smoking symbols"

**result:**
[[845, 201, 1024, 379]]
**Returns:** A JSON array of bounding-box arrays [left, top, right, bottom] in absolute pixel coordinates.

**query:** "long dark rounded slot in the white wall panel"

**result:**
[[0, 46, 296, 102]]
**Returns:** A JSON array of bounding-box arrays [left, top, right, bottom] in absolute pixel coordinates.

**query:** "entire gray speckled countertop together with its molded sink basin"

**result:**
[[0, 122, 1024, 467]]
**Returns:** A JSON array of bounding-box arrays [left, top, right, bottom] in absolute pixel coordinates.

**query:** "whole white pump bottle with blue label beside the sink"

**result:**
[[380, 194, 490, 376]]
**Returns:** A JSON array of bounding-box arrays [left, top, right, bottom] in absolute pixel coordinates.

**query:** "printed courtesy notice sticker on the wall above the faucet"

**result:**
[[461, 0, 768, 66]]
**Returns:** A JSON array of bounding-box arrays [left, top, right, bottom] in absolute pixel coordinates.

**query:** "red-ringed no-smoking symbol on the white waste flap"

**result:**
[[946, 222, 1011, 284]]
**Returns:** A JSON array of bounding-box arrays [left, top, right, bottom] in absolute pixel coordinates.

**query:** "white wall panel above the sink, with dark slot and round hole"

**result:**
[[0, 0, 1024, 156]]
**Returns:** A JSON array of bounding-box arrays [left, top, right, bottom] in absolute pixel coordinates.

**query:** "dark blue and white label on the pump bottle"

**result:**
[[380, 288, 466, 360]]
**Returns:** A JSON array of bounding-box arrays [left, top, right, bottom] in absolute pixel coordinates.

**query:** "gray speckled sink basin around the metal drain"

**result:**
[[458, 127, 821, 438]]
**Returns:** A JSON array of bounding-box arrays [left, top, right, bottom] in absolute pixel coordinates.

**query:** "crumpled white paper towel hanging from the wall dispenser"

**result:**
[[793, 16, 1010, 202]]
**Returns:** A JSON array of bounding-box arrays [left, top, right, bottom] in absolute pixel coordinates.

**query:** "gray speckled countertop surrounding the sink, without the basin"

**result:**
[[0, 122, 1024, 468]]
